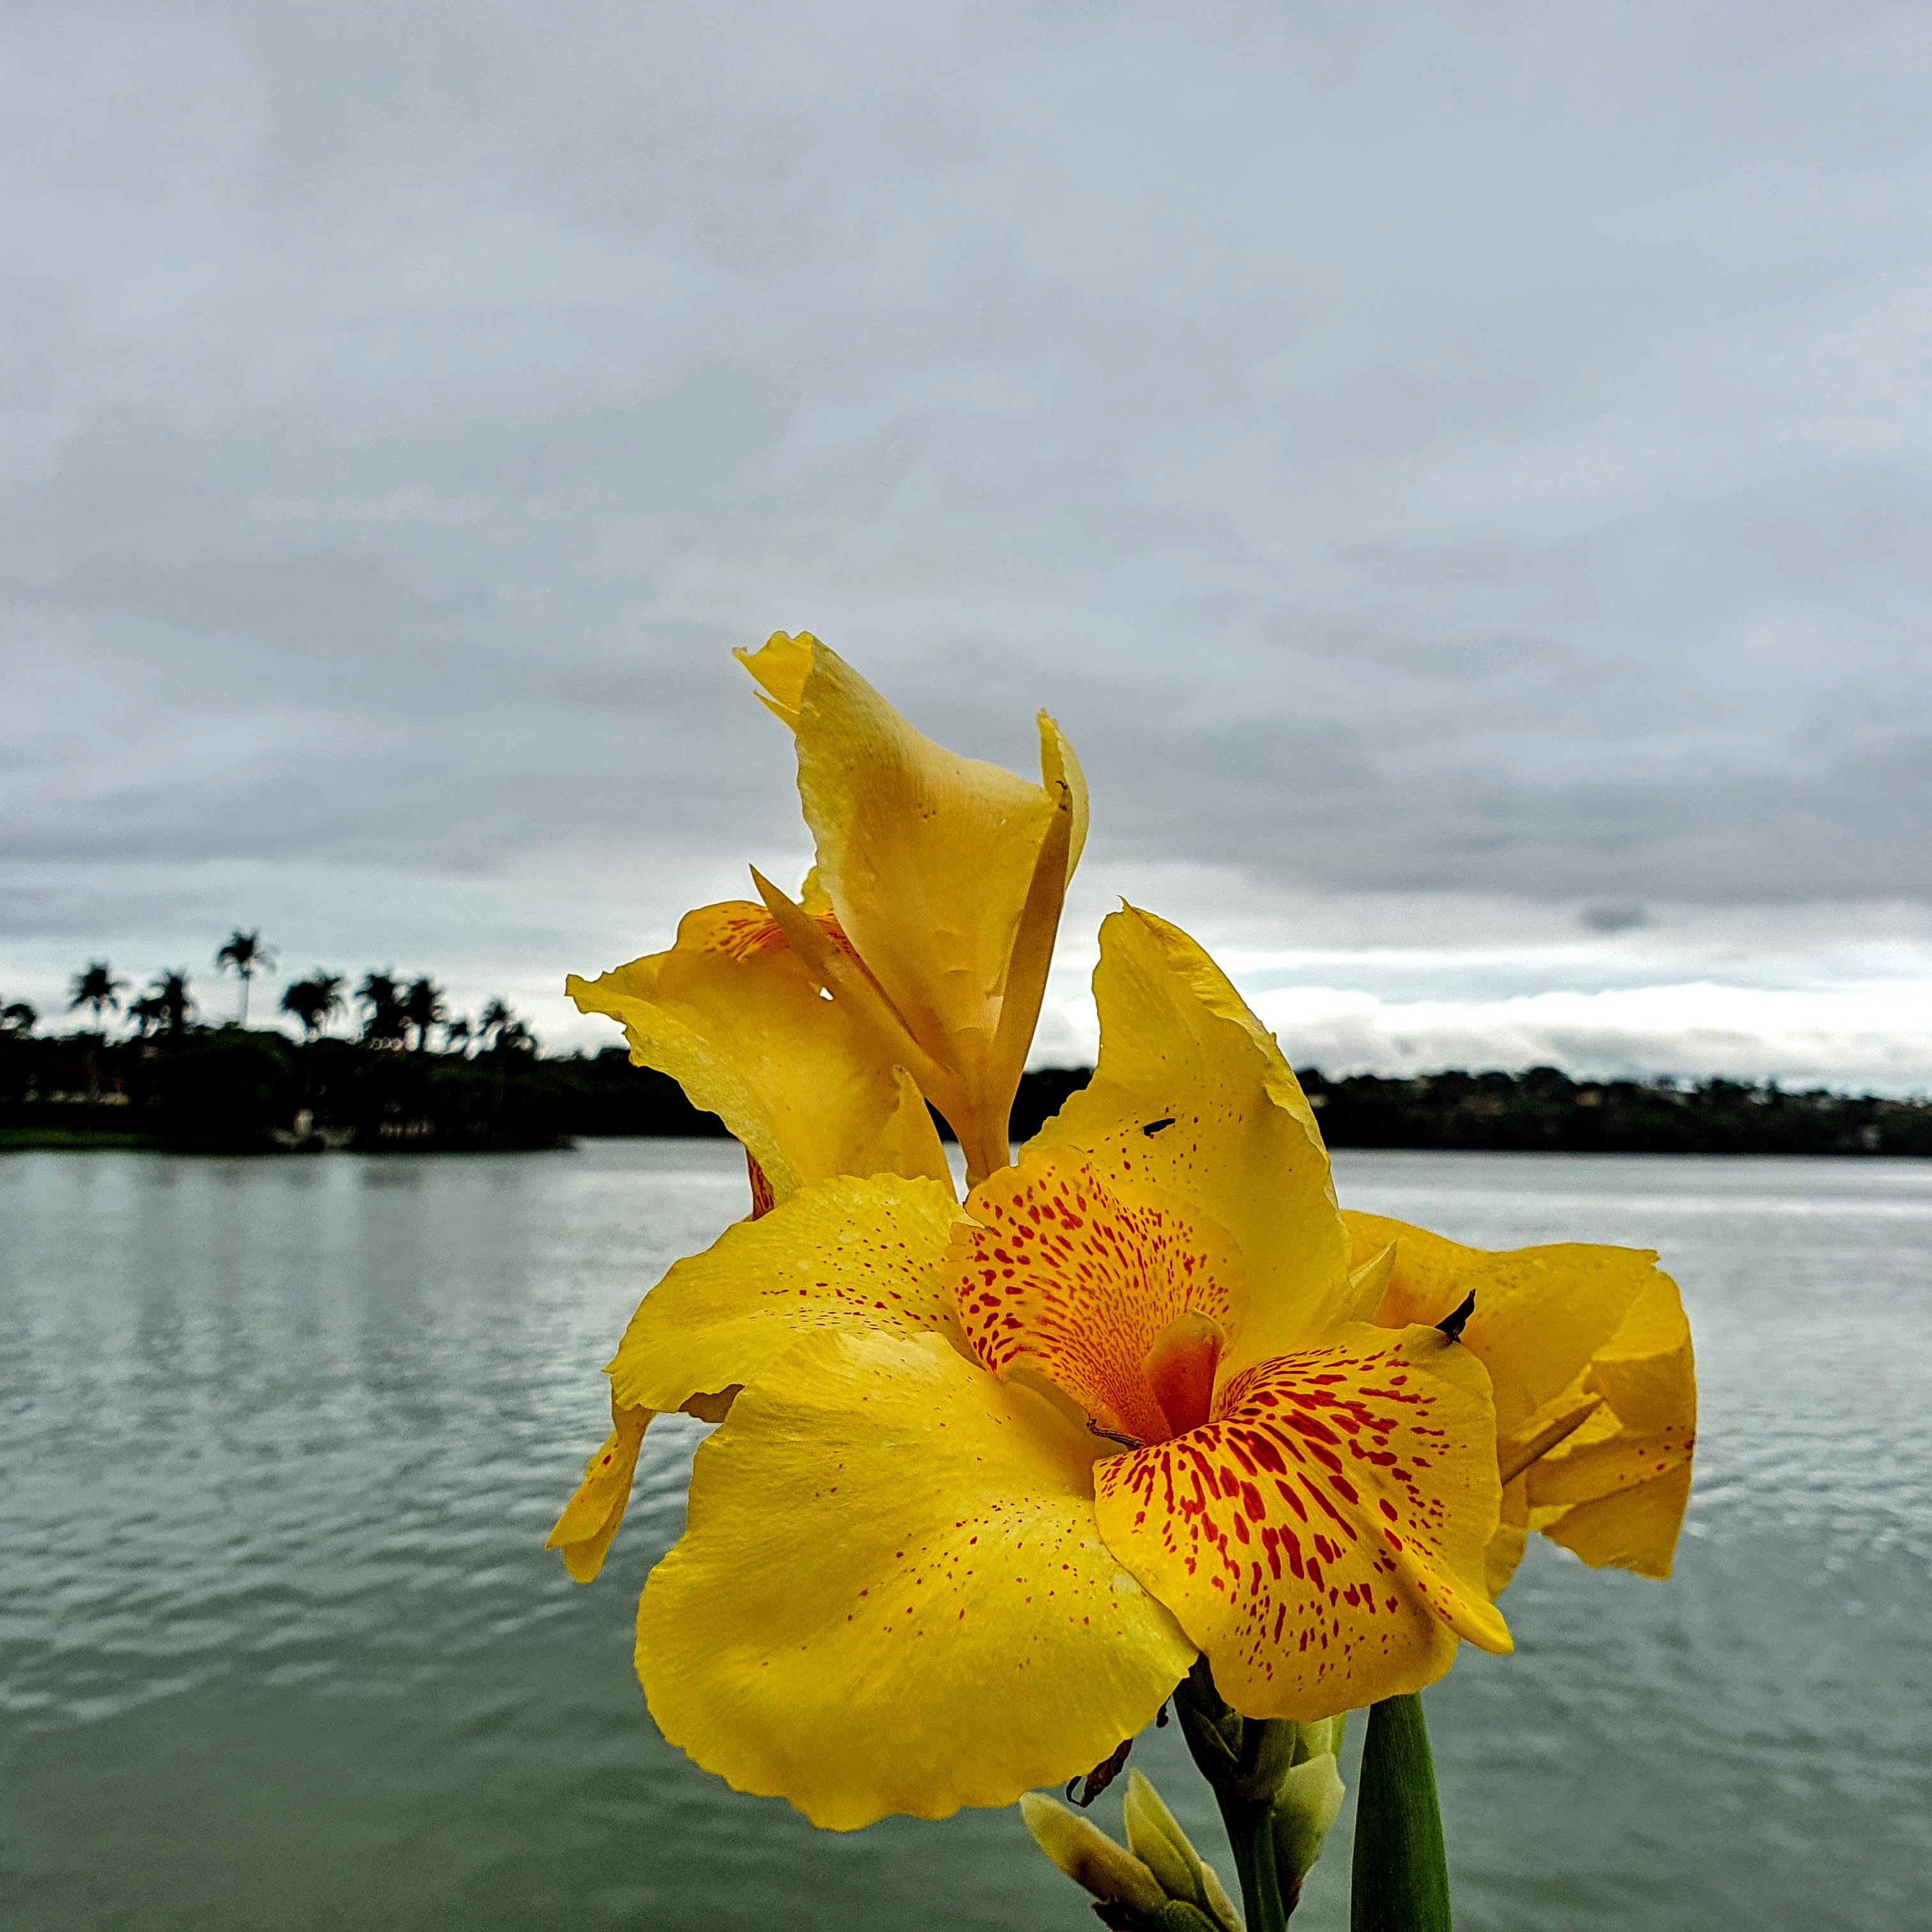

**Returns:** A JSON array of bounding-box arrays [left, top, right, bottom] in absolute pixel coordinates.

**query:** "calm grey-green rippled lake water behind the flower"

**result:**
[[0, 1142, 1932, 1932]]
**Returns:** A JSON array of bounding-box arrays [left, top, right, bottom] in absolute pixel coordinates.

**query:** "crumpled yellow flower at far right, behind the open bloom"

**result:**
[[1343, 1213, 1696, 1594]]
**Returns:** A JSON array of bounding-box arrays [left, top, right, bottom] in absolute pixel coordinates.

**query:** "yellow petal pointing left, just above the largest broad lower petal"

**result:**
[[611, 1175, 966, 1408]]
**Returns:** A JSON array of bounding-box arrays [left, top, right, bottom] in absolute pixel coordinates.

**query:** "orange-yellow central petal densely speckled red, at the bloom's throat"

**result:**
[[954, 1147, 1240, 1441]]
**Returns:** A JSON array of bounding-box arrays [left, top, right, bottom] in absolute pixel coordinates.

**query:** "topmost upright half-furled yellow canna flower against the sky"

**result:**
[[738, 630, 1085, 1181]]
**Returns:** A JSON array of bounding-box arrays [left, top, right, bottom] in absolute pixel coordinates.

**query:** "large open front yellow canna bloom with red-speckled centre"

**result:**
[[566, 910, 1509, 1828]]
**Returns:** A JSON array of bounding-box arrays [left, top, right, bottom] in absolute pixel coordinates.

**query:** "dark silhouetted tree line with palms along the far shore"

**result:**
[[0, 930, 1932, 1155]]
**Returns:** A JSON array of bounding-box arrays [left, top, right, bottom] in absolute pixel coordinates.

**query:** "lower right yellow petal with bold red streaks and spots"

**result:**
[[1096, 1323, 1511, 1721]]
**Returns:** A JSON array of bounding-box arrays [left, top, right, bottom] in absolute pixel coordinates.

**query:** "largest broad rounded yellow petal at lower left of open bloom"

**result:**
[[638, 1329, 1194, 1830]]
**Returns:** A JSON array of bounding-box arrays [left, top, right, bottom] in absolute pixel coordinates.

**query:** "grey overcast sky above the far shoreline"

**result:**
[[0, 0, 1932, 1090]]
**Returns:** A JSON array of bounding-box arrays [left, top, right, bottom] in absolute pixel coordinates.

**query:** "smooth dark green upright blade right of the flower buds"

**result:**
[[1349, 1694, 1449, 1932]]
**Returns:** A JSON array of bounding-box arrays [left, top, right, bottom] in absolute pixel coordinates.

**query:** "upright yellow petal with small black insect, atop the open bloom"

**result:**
[[1032, 906, 1353, 1376]]
